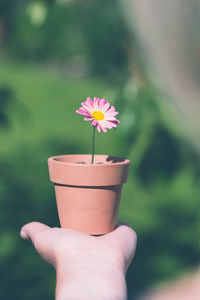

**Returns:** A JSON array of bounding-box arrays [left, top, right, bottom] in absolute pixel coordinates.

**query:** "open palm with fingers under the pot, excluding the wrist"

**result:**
[[21, 222, 136, 271]]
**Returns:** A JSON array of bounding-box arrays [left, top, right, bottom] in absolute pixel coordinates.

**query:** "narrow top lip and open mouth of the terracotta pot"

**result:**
[[48, 154, 130, 168]]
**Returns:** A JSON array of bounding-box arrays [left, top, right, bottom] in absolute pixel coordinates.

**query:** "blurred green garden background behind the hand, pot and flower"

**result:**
[[0, 0, 200, 300]]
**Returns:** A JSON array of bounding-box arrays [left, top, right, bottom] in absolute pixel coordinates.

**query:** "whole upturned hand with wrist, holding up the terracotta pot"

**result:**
[[20, 222, 136, 300]]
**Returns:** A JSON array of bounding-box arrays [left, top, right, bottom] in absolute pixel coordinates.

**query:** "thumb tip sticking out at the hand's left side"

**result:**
[[20, 222, 50, 243]]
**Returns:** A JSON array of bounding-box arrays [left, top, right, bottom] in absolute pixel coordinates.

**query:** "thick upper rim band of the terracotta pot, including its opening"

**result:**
[[48, 154, 130, 186]]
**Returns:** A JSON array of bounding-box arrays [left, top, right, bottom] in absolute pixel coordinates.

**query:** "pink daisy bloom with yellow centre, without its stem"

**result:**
[[76, 97, 120, 132]]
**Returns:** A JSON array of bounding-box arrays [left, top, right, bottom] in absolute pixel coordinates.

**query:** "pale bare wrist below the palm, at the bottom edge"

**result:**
[[56, 264, 127, 300]]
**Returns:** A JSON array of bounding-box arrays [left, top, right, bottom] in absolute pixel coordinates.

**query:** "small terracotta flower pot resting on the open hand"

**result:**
[[48, 155, 130, 235]]
